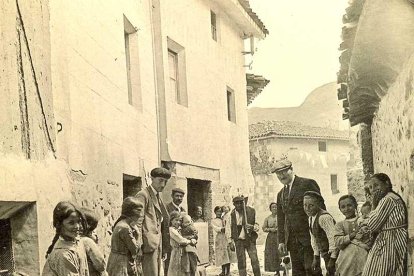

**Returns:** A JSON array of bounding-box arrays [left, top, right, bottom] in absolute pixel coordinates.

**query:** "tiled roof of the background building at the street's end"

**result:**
[[249, 121, 349, 140]]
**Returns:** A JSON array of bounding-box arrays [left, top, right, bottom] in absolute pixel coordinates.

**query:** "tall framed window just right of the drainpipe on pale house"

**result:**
[[167, 38, 188, 106]]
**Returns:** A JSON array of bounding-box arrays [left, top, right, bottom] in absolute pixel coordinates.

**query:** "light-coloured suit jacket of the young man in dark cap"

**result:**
[[136, 186, 169, 253]]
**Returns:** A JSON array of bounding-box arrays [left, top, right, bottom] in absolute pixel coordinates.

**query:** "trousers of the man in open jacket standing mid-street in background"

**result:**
[[235, 240, 260, 276]]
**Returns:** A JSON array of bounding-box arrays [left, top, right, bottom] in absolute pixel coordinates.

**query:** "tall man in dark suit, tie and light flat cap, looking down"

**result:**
[[272, 158, 326, 276]]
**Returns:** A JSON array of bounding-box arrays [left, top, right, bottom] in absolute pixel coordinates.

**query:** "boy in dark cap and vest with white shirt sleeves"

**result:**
[[303, 191, 338, 276]]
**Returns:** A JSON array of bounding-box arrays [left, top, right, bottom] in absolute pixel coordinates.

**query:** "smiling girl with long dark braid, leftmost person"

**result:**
[[42, 201, 89, 276]]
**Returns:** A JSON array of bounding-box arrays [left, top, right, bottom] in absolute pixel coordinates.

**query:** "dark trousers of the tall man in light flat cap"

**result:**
[[288, 235, 322, 276]]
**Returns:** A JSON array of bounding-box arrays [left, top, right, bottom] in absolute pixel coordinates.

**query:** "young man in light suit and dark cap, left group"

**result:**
[[136, 168, 171, 276]]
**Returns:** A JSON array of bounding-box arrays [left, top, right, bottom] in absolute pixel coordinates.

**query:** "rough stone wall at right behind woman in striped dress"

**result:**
[[371, 53, 414, 275]]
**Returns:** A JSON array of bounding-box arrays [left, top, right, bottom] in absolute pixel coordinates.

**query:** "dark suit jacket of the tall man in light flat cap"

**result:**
[[277, 176, 326, 250]]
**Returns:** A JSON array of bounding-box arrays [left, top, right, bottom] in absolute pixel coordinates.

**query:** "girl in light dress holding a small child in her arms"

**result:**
[[168, 211, 197, 276]]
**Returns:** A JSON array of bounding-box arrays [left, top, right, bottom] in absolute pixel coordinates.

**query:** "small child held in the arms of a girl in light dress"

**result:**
[[181, 215, 198, 276]]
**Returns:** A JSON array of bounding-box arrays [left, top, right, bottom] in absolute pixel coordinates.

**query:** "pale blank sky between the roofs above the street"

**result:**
[[246, 0, 348, 107]]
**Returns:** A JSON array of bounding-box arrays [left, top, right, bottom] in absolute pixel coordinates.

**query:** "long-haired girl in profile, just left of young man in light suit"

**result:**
[[107, 197, 143, 276]]
